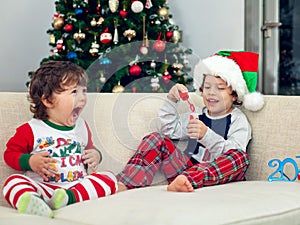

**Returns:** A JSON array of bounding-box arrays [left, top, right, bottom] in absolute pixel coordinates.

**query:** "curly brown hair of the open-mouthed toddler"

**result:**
[[28, 61, 87, 120]]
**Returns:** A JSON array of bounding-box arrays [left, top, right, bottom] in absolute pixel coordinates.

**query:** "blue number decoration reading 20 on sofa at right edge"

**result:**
[[268, 156, 300, 182]]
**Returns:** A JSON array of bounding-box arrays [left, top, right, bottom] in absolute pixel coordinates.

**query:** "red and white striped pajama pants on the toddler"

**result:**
[[3, 172, 118, 208]]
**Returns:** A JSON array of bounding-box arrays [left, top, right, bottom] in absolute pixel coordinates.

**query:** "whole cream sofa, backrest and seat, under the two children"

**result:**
[[0, 92, 300, 225]]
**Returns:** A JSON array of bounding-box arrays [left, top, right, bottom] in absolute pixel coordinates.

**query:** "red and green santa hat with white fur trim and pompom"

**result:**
[[194, 51, 264, 111]]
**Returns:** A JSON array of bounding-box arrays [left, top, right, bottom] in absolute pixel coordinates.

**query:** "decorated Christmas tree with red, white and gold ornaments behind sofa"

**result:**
[[32, 0, 192, 92]]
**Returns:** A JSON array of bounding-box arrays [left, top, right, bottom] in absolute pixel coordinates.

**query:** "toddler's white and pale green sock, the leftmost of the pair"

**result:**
[[18, 192, 54, 218]]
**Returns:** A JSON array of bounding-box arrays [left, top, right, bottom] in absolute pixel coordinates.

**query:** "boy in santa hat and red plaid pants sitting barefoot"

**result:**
[[117, 51, 264, 192]]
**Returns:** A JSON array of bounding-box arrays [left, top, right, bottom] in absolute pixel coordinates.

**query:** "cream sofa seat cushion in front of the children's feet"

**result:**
[[55, 181, 300, 225]]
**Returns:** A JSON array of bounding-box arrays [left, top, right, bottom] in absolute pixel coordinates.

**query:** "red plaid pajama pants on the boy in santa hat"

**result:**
[[117, 132, 249, 189]]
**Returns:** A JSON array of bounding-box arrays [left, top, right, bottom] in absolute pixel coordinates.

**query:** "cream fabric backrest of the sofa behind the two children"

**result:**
[[0, 92, 300, 205]]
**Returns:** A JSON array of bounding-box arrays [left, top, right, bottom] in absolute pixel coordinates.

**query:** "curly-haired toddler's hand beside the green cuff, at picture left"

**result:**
[[28, 151, 57, 181]]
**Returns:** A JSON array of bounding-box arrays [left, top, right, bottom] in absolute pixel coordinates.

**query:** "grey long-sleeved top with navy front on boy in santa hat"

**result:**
[[159, 100, 251, 162]]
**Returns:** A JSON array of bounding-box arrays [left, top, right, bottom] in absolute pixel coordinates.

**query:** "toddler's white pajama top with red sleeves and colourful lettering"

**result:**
[[4, 118, 95, 188]]
